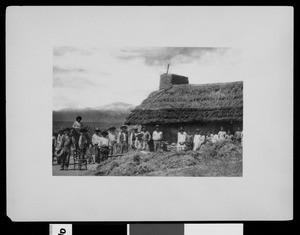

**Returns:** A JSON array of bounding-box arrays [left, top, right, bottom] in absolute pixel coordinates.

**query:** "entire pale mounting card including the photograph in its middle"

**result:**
[[6, 6, 294, 224]]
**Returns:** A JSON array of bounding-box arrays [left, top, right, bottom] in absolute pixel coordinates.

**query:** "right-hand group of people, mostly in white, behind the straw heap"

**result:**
[[177, 126, 243, 151]]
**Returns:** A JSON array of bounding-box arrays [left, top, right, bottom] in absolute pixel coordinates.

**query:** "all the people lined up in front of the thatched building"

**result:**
[[52, 116, 243, 170]]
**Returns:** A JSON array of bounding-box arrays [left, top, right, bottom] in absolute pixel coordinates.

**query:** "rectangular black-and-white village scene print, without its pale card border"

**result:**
[[52, 46, 243, 177]]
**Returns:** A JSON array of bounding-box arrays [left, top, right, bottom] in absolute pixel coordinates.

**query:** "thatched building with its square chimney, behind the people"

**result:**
[[125, 74, 243, 142]]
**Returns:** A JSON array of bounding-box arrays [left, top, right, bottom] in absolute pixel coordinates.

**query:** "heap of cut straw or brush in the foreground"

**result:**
[[93, 142, 243, 177]]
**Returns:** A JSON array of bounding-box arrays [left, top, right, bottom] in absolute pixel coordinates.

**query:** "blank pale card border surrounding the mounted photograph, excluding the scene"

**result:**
[[6, 6, 293, 221]]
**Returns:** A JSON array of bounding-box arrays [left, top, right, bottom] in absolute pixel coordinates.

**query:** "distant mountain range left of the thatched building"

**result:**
[[53, 102, 135, 123]]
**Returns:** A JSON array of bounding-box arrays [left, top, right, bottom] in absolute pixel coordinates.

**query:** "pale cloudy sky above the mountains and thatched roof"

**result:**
[[53, 46, 243, 110]]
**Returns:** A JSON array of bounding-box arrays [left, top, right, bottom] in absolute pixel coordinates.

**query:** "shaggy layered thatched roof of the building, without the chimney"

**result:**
[[125, 82, 243, 124]]
